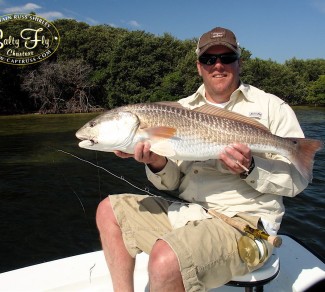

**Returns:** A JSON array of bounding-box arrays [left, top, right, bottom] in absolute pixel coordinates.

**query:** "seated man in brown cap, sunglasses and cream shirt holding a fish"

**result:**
[[97, 27, 308, 292]]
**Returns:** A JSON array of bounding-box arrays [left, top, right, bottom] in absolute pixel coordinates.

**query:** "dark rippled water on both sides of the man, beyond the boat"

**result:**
[[0, 108, 325, 272]]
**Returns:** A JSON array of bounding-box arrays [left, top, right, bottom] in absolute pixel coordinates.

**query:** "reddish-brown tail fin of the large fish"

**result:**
[[290, 138, 324, 182]]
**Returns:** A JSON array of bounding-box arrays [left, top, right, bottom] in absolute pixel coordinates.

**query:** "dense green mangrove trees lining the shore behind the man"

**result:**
[[0, 19, 325, 115]]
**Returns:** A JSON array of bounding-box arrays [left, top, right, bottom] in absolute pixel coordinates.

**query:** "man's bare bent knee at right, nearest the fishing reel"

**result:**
[[148, 240, 184, 292]]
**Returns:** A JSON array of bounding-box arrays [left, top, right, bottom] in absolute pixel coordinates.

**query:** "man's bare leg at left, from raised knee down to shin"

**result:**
[[96, 198, 135, 292]]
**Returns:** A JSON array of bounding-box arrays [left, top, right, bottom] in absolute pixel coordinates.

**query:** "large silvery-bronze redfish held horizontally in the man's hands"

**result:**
[[76, 102, 324, 181]]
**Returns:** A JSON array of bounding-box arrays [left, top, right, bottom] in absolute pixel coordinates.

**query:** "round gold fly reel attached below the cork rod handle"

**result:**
[[238, 235, 268, 267]]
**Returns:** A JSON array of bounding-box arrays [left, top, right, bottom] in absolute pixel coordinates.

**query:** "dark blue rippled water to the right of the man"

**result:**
[[281, 107, 325, 258]]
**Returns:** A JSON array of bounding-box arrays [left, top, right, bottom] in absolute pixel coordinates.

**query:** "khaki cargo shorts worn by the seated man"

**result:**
[[109, 194, 270, 291]]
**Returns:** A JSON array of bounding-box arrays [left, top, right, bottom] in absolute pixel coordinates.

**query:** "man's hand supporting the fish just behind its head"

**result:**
[[114, 142, 167, 172]]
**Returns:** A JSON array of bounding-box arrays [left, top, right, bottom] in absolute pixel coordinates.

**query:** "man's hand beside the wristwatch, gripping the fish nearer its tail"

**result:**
[[220, 144, 252, 174]]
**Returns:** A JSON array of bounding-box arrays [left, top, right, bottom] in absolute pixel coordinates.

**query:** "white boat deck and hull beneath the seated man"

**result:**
[[0, 235, 325, 292]]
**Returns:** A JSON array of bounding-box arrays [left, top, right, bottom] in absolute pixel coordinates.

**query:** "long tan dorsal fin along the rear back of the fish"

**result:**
[[193, 104, 270, 133]]
